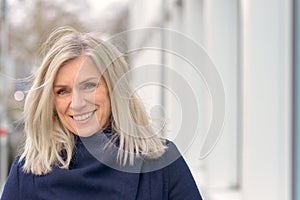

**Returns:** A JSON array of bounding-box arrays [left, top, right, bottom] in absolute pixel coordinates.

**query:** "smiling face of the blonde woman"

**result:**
[[53, 55, 111, 137]]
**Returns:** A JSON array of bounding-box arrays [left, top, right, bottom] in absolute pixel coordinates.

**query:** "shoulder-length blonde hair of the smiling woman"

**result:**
[[20, 27, 166, 175]]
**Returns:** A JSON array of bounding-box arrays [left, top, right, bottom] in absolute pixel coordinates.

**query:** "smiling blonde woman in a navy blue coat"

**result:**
[[1, 28, 201, 200]]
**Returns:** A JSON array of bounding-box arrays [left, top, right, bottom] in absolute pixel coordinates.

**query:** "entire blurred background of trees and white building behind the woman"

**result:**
[[0, 0, 300, 200]]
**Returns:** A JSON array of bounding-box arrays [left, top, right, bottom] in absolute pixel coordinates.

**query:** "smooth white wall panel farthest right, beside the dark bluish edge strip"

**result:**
[[242, 0, 292, 200]]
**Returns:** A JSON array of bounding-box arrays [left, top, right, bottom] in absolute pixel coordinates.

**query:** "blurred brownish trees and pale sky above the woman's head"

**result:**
[[9, 0, 127, 77]]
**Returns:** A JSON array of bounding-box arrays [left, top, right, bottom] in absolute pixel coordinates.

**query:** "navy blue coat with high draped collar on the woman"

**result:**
[[1, 129, 202, 200]]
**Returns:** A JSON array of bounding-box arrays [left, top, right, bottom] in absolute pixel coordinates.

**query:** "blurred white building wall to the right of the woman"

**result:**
[[127, 0, 292, 200]]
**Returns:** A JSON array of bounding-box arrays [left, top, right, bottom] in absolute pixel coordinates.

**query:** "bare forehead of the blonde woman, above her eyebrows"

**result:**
[[55, 55, 101, 83]]
